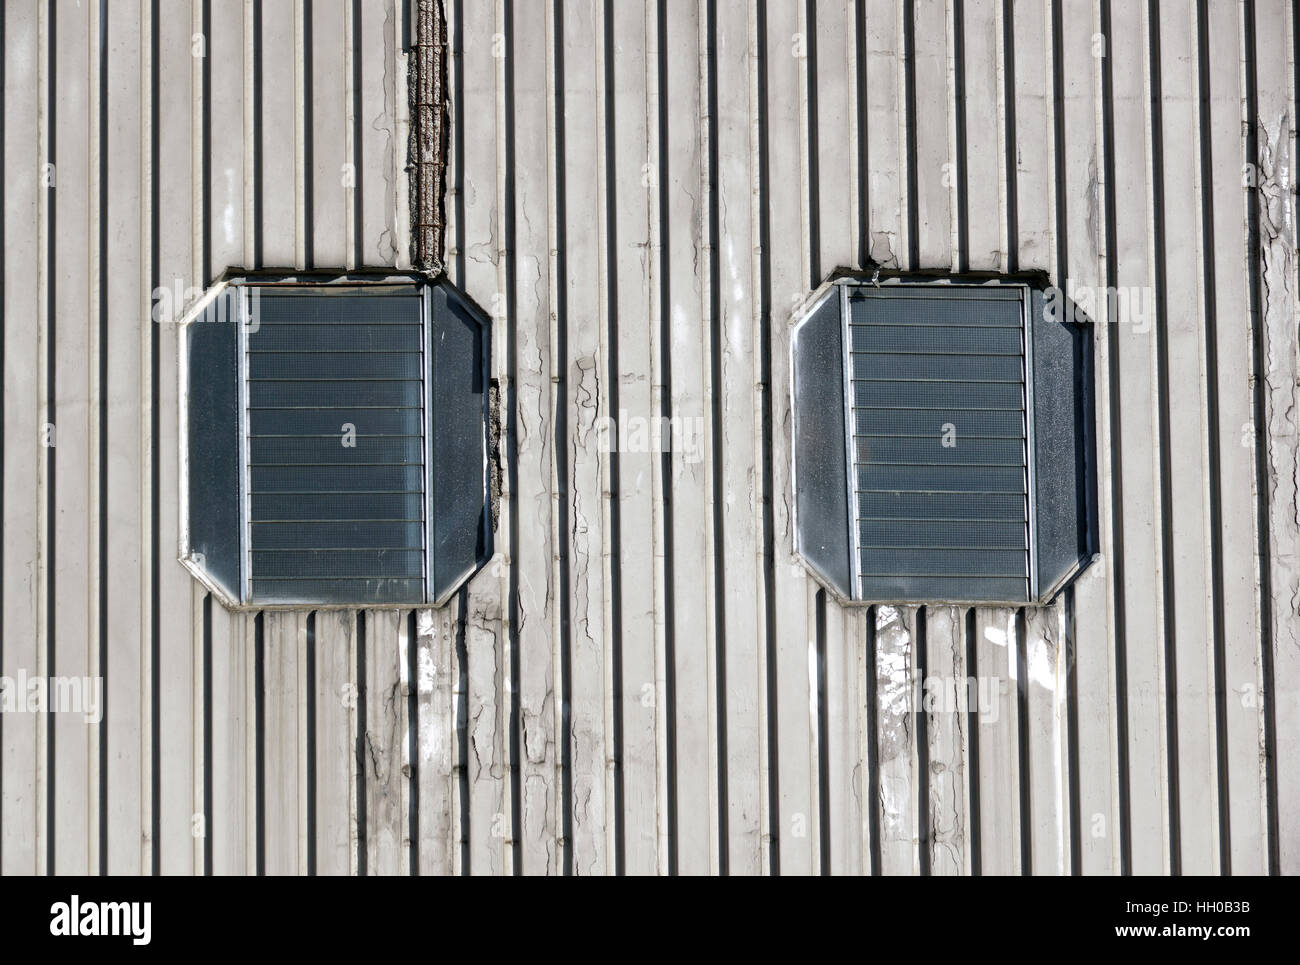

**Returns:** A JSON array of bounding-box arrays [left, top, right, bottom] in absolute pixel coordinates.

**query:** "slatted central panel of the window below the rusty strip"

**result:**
[[244, 289, 425, 603]]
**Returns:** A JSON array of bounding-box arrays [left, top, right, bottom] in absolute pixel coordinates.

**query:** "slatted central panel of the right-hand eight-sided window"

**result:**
[[846, 286, 1031, 602]]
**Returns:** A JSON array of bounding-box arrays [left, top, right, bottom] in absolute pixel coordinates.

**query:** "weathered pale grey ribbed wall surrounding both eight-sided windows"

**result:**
[[0, 0, 1300, 874]]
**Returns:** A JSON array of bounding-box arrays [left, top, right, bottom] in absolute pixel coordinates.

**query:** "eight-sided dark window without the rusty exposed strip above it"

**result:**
[[792, 277, 1096, 605]]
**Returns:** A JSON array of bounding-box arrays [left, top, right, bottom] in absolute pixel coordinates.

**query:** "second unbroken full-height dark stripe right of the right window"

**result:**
[[1147, 0, 1183, 875]]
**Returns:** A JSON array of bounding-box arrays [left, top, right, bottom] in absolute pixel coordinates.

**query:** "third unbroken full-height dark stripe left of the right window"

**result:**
[[655, 0, 681, 875]]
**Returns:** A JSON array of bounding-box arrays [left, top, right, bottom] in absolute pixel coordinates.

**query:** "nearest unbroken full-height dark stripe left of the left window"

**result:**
[[150, 0, 160, 875]]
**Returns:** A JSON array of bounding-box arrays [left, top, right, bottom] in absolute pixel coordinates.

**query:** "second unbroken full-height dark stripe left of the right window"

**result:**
[[705, 0, 731, 875]]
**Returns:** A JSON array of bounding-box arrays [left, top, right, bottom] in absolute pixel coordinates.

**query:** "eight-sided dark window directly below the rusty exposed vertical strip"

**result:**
[[181, 276, 490, 606]]
